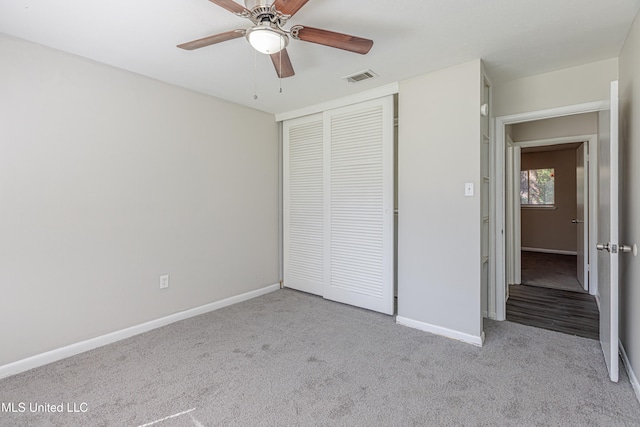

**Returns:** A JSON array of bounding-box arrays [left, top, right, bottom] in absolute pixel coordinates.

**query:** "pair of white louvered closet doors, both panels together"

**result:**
[[283, 96, 394, 314]]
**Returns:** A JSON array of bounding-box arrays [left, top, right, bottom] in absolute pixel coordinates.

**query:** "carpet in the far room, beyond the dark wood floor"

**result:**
[[521, 251, 585, 292]]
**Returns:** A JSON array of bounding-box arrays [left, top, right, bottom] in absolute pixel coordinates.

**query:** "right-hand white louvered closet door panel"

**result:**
[[323, 96, 394, 314]]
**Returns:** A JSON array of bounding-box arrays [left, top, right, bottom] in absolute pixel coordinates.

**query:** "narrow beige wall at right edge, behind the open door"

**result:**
[[620, 12, 640, 399]]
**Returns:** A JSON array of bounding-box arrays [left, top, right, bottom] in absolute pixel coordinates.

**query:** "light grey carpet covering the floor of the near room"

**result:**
[[0, 289, 640, 426]]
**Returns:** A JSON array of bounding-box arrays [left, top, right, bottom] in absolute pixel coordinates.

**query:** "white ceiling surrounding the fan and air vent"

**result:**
[[0, 0, 640, 113]]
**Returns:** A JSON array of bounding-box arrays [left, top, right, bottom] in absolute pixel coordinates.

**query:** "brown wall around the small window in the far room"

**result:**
[[521, 149, 577, 252]]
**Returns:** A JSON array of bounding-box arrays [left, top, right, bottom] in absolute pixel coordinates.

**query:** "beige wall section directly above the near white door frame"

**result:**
[[493, 58, 618, 117]]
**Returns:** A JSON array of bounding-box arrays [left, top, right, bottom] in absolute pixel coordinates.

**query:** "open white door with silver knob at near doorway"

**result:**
[[597, 81, 619, 382]]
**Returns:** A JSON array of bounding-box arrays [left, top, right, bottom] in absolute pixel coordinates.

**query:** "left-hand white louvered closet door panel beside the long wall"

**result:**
[[283, 114, 324, 295]]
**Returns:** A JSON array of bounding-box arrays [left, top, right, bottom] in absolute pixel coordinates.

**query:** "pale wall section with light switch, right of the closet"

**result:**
[[398, 60, 482, 338]]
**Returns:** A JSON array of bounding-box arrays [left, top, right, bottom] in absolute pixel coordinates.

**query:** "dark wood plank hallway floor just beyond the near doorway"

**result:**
[[507, 285, 599, 340]]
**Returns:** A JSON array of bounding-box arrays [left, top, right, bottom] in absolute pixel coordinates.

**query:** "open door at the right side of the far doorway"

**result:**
[[573, 143, 589, 291]]
